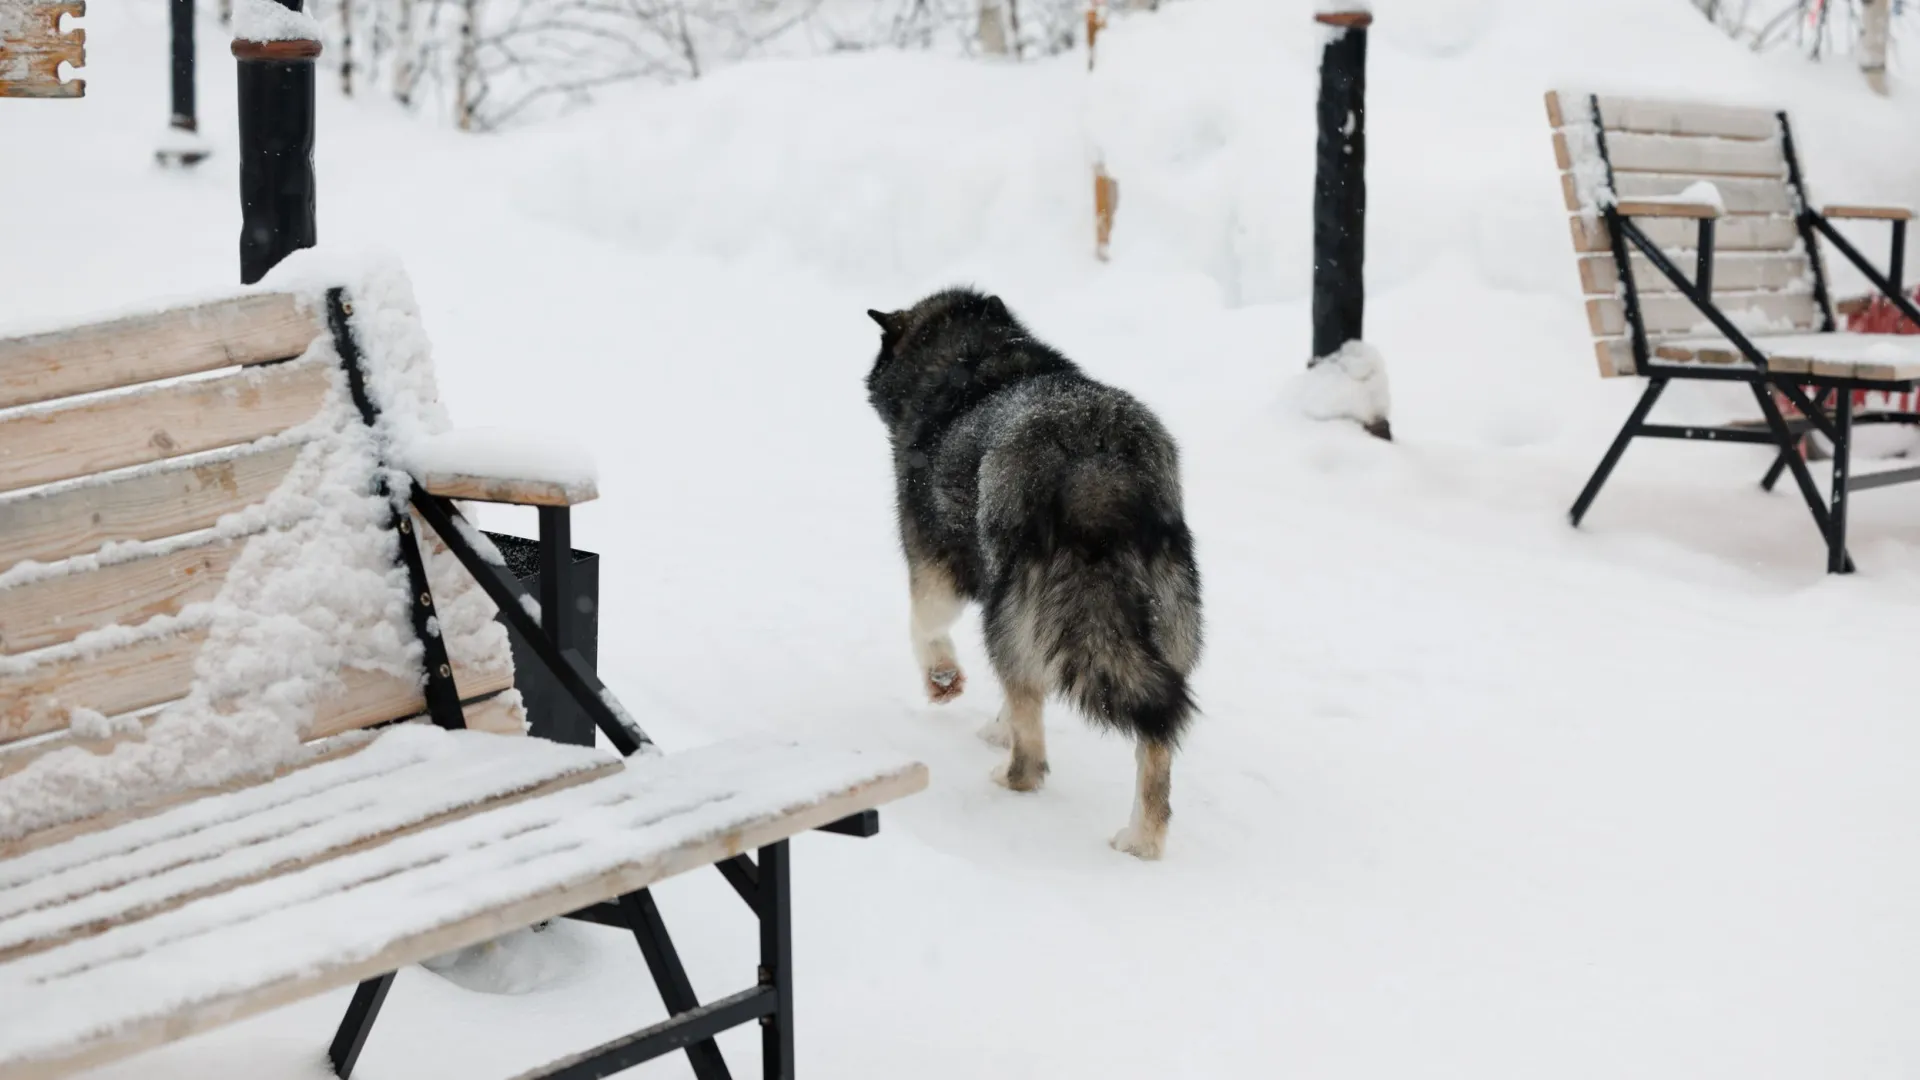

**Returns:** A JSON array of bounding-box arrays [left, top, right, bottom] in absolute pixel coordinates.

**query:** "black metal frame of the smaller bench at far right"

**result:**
[[1569, 96, 1920, 573]]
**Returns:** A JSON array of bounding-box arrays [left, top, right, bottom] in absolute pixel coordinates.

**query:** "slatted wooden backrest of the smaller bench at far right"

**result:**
[[1548, 90, 1826, 377]]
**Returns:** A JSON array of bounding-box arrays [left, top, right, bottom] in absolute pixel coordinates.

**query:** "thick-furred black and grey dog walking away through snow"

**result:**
[[866, 288, 1200, 859]]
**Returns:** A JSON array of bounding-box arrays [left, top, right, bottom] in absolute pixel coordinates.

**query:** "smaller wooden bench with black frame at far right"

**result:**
[[1548, 90, 1920, 573]]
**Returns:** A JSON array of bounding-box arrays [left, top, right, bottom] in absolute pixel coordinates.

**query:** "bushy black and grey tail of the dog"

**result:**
[[1014, 454, 1200, 746]]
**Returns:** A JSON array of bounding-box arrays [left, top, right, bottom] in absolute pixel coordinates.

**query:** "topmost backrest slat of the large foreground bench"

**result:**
[[0, 292, 321, 407]]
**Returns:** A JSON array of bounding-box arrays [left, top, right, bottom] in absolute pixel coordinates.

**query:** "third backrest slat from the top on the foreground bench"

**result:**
[[0, 444, 300, 573]]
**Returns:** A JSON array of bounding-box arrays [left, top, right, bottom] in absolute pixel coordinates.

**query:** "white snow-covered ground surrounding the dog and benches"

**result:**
[[11, 0, 1920, 1080]]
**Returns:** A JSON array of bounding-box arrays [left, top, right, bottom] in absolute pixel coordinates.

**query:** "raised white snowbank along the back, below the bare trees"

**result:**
[[522, 0, 1920, 306]]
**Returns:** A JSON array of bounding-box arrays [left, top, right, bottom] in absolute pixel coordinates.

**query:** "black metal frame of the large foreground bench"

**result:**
[[326, 288, 879, 1080]]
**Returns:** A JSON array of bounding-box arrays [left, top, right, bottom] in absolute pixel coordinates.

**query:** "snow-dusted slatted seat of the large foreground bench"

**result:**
[[0, 724, 925, 1080]]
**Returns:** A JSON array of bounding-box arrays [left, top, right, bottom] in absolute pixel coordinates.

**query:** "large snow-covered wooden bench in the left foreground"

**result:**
[[0, 269, 925, 1080]]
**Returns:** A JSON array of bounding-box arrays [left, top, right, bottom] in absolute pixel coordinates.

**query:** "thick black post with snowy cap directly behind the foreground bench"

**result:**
[[234, 0, 321, 284]]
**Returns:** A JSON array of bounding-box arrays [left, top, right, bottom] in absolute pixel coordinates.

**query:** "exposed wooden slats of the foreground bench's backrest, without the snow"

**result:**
[[0, 292, 518, 840]]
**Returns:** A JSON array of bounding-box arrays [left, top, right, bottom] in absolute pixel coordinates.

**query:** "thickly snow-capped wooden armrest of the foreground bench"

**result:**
[[405, 429, 599, 505]]
